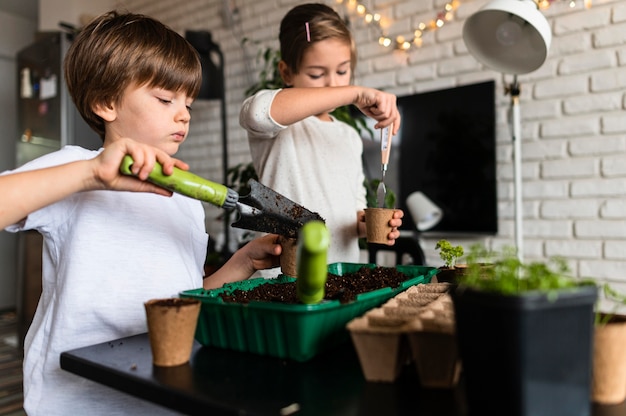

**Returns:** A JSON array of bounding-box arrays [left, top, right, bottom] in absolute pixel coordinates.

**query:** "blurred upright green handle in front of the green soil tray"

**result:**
[[296, 221, 330, 304]]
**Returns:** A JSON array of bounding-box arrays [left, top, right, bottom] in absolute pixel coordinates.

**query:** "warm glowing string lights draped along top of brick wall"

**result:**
[[336, 0, 593, 51]]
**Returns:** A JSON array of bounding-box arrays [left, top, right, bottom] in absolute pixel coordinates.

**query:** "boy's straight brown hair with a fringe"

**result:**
[[64, 11, 202, 140]]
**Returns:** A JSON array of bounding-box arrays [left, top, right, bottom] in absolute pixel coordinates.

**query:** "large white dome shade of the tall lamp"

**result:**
[[463, 0, 552, 75]]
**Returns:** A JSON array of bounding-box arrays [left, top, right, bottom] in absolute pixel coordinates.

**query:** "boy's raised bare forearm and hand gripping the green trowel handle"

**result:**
[[0, 139, 188, 228]]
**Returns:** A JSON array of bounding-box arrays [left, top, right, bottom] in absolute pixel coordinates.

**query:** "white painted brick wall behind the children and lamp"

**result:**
[[120, 0, 626, 282]]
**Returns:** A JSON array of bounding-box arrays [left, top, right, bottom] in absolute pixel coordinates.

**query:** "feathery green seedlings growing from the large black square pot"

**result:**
[[463, 246, 595, 298]]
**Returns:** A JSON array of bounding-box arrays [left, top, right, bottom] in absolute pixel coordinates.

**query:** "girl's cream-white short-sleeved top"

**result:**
[[239, 90, 367, 272]]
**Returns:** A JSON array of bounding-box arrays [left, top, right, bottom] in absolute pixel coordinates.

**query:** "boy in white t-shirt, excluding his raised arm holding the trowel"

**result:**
[[2, 12, 280, 416]]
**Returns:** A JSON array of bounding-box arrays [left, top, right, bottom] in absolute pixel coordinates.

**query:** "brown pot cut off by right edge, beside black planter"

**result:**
[[591, 315, 626, 404]]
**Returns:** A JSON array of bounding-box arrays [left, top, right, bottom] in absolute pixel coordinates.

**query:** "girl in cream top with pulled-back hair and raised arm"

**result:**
[[240, 4, 404, 270]]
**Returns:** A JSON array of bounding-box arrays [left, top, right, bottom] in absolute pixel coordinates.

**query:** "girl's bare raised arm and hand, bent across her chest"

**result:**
[[270, 85, 400, 134]]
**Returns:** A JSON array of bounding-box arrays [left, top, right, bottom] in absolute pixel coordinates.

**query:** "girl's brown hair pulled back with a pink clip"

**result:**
[[278, 3, 356, 74]]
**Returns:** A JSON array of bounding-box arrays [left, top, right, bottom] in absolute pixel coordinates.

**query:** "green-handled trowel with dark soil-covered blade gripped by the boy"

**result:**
[[120, 156, 324, 238]]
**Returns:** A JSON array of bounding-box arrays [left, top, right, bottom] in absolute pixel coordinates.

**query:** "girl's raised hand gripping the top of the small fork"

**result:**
[[353, 88, 400, 136]]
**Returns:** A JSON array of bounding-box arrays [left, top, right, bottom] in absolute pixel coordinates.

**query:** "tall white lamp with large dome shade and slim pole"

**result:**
[[463, 0, 552, 261]]
